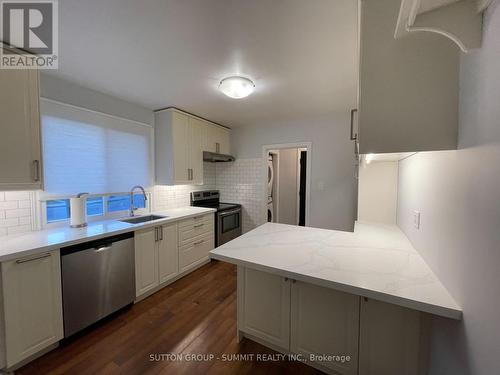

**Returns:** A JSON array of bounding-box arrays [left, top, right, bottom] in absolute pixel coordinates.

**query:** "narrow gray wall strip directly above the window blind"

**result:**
[[40, 73, 154, 125]]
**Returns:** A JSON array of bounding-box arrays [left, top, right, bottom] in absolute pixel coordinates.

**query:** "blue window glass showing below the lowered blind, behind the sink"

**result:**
[[46, 194, 147, 224]]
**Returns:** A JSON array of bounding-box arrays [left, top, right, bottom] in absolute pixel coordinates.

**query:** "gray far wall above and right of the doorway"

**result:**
[[231, 111, 357, 231]]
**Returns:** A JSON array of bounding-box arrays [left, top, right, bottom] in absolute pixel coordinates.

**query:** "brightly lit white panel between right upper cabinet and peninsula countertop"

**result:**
[[358, 161, 398, 224]]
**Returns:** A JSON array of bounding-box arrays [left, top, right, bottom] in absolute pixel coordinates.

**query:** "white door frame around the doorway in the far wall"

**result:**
[[261, 142, 312, 227]]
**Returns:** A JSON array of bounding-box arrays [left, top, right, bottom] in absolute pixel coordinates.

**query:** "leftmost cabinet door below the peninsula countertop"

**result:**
[[238, 267, 290, 350]]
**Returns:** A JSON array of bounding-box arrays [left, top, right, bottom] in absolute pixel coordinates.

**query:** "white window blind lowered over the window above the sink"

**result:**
[[40, 99, 153, 195]]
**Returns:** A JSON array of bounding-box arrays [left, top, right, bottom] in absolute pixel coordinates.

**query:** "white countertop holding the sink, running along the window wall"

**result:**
[[0, 207, 215, 262]]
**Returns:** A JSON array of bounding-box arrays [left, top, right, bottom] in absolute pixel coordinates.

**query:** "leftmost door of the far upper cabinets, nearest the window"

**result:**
[[172, 112, 192, 184]]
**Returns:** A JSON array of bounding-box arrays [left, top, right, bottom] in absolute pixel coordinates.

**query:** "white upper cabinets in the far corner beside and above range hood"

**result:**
[[155, 109, 230, 185]]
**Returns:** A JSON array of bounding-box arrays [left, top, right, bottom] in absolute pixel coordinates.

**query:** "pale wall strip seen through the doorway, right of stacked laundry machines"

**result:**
[[277, 148, 298, 225]]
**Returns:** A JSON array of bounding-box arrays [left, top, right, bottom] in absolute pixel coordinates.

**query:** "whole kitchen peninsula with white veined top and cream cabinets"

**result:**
[[210, 222, 462, 375]]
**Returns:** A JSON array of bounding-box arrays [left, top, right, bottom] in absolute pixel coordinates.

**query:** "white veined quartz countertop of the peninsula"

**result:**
[[210, 222, 462, 319]]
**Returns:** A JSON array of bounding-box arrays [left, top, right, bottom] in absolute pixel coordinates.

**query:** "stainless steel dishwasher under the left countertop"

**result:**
[[61, 233, 135, 337]]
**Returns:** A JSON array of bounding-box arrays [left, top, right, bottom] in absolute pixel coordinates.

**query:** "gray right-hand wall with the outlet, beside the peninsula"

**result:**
[[398, 2, 500, 375]]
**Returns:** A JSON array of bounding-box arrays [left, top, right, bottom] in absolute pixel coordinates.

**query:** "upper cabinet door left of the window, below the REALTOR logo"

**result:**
[[0, 70, 42, 190]]
